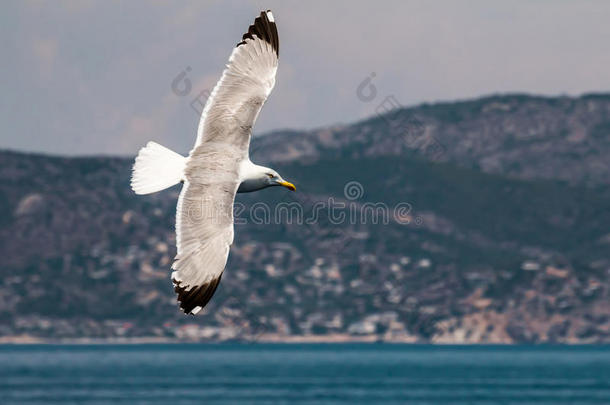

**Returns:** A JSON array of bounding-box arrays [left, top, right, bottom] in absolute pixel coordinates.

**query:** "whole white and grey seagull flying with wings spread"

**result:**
[[131, 10, 296, 315]]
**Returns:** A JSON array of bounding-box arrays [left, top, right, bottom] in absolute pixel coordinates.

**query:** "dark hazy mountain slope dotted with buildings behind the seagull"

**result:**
[[0, 94, 610, 343]]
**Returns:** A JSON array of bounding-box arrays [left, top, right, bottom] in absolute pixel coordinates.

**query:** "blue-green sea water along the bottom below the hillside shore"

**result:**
[[0, 344, 610, 405]]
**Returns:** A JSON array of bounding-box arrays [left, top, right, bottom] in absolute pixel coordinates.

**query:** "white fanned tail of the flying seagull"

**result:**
[[131, 142, 186, 194]]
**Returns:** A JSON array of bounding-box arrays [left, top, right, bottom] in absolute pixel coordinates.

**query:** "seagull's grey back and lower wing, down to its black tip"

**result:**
[[172, 143, 241, 314]]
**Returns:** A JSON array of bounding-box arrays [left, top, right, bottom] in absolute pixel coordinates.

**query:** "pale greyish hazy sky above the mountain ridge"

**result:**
[[0, 0, 610, 155]]
